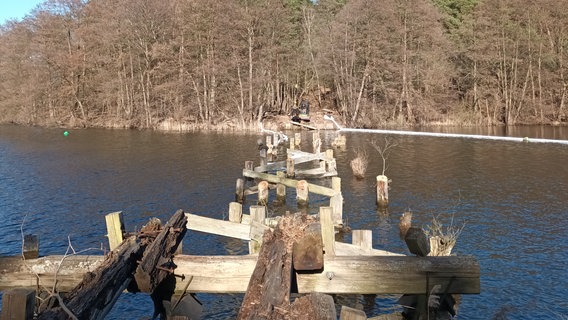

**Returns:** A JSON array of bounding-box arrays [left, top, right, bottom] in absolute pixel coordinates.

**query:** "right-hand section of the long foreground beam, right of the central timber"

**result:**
[[296, 256, 480, 294]]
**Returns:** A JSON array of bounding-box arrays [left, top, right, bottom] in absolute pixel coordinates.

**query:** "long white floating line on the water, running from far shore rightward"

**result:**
[[324, 115, 568, 145]]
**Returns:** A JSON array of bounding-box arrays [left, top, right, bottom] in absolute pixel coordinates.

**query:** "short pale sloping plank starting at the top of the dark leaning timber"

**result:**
[[185, 213, 250, 240]]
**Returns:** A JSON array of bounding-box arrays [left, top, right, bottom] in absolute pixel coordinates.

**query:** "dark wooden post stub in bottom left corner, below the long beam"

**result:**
[[0, 288, 35, 320]]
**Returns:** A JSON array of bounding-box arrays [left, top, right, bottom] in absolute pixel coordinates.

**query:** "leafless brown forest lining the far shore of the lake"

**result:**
[[0, 0, 568, 128]]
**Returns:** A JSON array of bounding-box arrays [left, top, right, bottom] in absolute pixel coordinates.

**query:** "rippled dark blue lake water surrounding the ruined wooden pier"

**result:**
[[0, 126, 568, 319]]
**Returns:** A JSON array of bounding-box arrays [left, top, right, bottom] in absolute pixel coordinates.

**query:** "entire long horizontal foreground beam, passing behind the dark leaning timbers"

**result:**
[[0, 255, 480, 294]]
